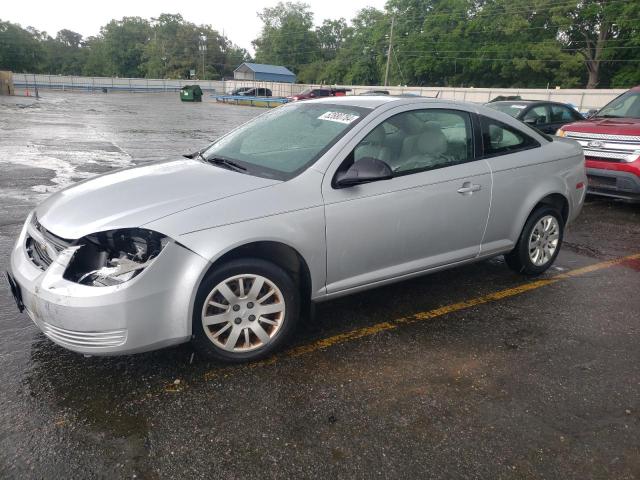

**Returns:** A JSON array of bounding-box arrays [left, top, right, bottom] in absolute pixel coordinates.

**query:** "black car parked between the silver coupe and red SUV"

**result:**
[[485, 100, 584, 134]]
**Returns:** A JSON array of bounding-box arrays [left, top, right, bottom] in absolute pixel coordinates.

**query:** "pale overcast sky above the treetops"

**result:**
[[0, 0, 386, 53]]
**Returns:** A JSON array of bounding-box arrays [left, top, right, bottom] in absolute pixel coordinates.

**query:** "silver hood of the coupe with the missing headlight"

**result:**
[[36, 159, 281, 239]]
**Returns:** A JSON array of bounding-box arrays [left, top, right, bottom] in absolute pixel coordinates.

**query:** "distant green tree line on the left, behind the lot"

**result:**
[[0, 14, 249, 79]]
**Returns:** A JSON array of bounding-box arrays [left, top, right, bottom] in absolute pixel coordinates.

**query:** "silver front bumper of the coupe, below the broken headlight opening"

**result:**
[[10, 216, 208, 355]]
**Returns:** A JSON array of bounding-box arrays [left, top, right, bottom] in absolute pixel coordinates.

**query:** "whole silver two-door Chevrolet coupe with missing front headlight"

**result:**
[[8, 96, 586, 361]]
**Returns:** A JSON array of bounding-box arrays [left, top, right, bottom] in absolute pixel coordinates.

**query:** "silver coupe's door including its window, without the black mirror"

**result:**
[[323, 107, 492, 294]]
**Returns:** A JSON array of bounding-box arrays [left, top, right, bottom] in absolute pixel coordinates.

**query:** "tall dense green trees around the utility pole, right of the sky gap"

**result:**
[[254, 0, 640, 88]]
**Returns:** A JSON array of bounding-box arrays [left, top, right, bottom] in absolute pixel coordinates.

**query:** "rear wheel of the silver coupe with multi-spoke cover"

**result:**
[[504, 206, 564, 275]]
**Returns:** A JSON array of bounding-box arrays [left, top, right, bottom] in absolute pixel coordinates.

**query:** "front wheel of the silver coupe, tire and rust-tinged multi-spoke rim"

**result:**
[[192, 258, 300, 362]]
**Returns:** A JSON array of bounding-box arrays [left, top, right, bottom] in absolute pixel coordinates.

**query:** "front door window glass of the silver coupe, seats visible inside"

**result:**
[[353, 108, 474, 174]]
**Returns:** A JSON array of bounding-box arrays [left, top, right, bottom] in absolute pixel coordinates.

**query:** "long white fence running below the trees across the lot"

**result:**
[[13, 73, 625, 111]]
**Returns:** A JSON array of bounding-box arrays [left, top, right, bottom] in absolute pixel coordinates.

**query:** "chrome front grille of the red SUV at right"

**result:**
[[566, 131, 640, 162]]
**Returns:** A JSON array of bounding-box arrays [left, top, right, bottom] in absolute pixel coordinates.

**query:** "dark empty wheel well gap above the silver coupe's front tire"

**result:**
[[209, 241, 311, 315]]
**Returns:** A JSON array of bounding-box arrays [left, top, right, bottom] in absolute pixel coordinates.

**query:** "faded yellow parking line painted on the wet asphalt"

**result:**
[[205, 253, 640, 380]]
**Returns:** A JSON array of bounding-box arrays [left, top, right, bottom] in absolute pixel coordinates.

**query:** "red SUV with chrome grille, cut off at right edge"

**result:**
[[557, 86, 640, 202]]
